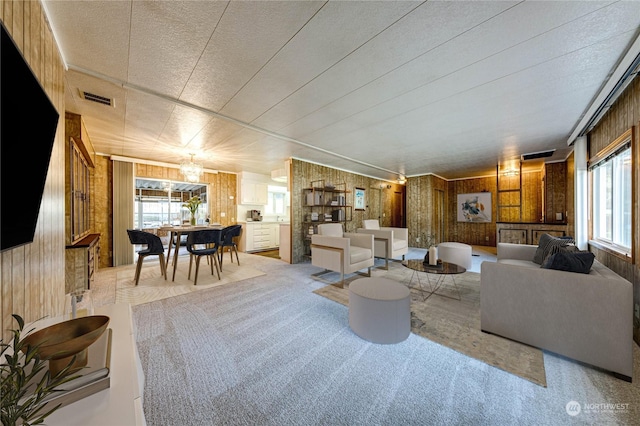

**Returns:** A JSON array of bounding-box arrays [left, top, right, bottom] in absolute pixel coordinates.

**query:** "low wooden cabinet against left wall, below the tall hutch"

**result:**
[[65, 234, 100, 293]]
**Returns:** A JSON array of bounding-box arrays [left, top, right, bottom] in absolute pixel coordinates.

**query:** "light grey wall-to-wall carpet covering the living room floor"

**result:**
[[94, 248, 640, 426]]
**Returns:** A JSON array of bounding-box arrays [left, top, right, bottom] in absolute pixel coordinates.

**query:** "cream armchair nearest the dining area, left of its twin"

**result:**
[[311, 223, 375, 287]]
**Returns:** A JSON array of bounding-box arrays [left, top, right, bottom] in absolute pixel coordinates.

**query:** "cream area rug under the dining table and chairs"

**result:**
[[116, 256, 265, 306]]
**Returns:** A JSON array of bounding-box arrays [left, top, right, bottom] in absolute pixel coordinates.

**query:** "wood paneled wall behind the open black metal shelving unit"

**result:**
[[290, 159, 404, 263]]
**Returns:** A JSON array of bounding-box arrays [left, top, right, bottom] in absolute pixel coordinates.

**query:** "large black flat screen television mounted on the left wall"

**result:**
[[0, 22, 59, 251]]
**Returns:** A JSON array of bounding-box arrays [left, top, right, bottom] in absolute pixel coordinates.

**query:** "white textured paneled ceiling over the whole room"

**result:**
[[44, 0, 640, 180]]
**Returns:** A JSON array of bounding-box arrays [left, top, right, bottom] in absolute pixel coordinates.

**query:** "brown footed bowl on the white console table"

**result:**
[[23, 315, 109, 375]]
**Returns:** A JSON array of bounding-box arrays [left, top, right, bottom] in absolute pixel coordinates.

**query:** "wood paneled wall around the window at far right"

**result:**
[[588, 77, 640, 344]]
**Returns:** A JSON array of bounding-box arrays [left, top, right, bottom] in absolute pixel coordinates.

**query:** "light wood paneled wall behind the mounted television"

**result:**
[[0, 0, 65, 340]]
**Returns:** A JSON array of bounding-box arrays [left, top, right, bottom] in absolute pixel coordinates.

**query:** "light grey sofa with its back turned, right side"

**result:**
[[480, 243, 634, 381]]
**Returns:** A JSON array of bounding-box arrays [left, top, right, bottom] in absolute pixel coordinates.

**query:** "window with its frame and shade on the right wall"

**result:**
[[589, 128, 635, 258]]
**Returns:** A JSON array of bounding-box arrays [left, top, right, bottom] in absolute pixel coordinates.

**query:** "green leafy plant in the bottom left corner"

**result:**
[[0, 314, 79, 426]]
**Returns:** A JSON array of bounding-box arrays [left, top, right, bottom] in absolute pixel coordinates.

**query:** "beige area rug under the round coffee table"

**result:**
[[314, 262, 547, 387]]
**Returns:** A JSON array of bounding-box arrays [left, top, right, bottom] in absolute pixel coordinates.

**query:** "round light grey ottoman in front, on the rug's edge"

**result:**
[[349, 277, 411, 344]]
